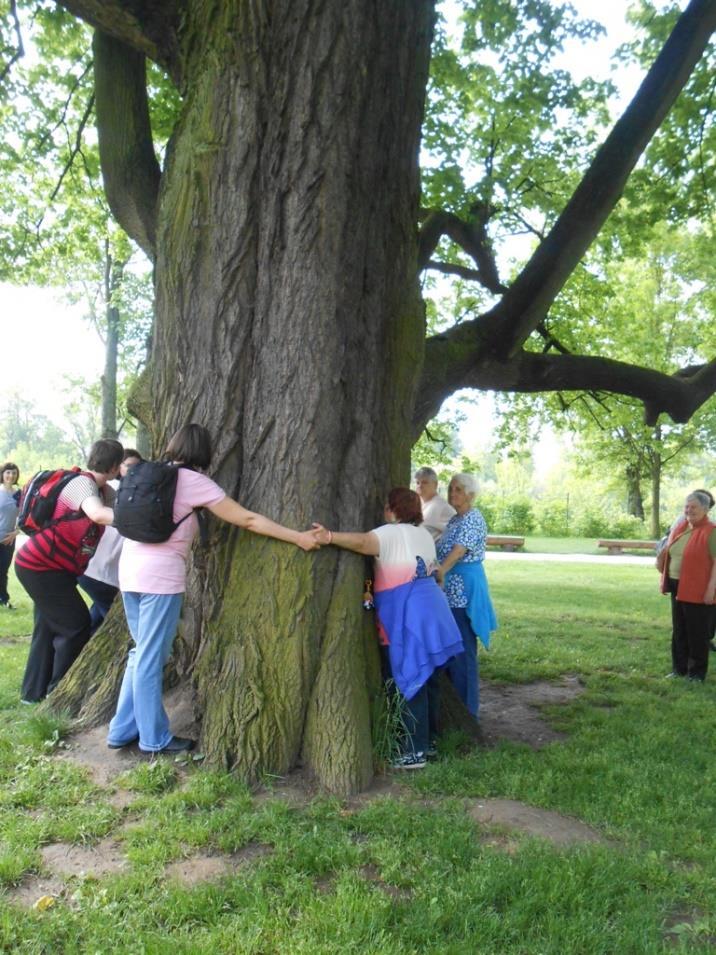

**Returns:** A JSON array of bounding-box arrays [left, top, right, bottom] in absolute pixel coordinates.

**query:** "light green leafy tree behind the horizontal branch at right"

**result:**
[[500, 224, 716, 537]]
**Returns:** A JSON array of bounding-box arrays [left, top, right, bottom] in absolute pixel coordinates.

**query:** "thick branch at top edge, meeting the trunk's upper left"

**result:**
[[57, 0, 186, 85]]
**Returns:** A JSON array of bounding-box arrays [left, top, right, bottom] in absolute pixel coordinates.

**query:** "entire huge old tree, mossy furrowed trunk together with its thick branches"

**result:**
[[5, 0, 716, 791]]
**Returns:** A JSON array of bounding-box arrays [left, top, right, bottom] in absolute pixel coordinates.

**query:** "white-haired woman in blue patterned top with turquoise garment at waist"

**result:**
[[437, 474, 497, 718]]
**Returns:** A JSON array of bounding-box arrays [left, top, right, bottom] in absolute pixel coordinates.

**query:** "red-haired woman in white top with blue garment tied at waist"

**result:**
[[314, 487, 463, 769]]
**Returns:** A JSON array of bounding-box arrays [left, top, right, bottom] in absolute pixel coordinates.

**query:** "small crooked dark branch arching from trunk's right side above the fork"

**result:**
[[418, 206, 505, 295]]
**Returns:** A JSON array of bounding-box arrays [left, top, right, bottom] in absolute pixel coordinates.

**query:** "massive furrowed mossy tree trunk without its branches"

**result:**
[[53, 0, 432, 793]]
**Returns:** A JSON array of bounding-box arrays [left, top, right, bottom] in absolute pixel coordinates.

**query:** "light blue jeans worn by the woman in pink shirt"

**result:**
[[107, 591, 184, 753]]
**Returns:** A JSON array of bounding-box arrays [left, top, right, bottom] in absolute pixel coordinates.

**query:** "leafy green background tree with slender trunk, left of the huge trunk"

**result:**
[[0, 4, 159, 439]]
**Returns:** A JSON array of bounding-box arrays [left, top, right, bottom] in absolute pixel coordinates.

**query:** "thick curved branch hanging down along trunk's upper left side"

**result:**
[[93, 31, 161, 259]]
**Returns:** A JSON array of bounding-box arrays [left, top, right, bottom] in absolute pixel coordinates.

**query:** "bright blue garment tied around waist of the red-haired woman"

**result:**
[[375, 577, 463, 700]]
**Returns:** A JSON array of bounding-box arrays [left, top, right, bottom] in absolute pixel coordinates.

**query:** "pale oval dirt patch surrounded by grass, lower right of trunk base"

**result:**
[[469, 799, 610, 846]]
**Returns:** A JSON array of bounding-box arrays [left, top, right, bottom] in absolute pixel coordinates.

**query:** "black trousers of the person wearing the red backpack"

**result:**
[[15, 564, 90, 703]]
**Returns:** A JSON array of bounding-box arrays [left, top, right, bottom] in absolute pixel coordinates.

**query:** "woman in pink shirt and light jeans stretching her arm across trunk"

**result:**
[[107, 424, 318, 753]]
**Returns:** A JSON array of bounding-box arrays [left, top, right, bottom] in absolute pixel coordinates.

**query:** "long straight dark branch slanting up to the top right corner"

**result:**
[[476, 0, 716, 357]]
